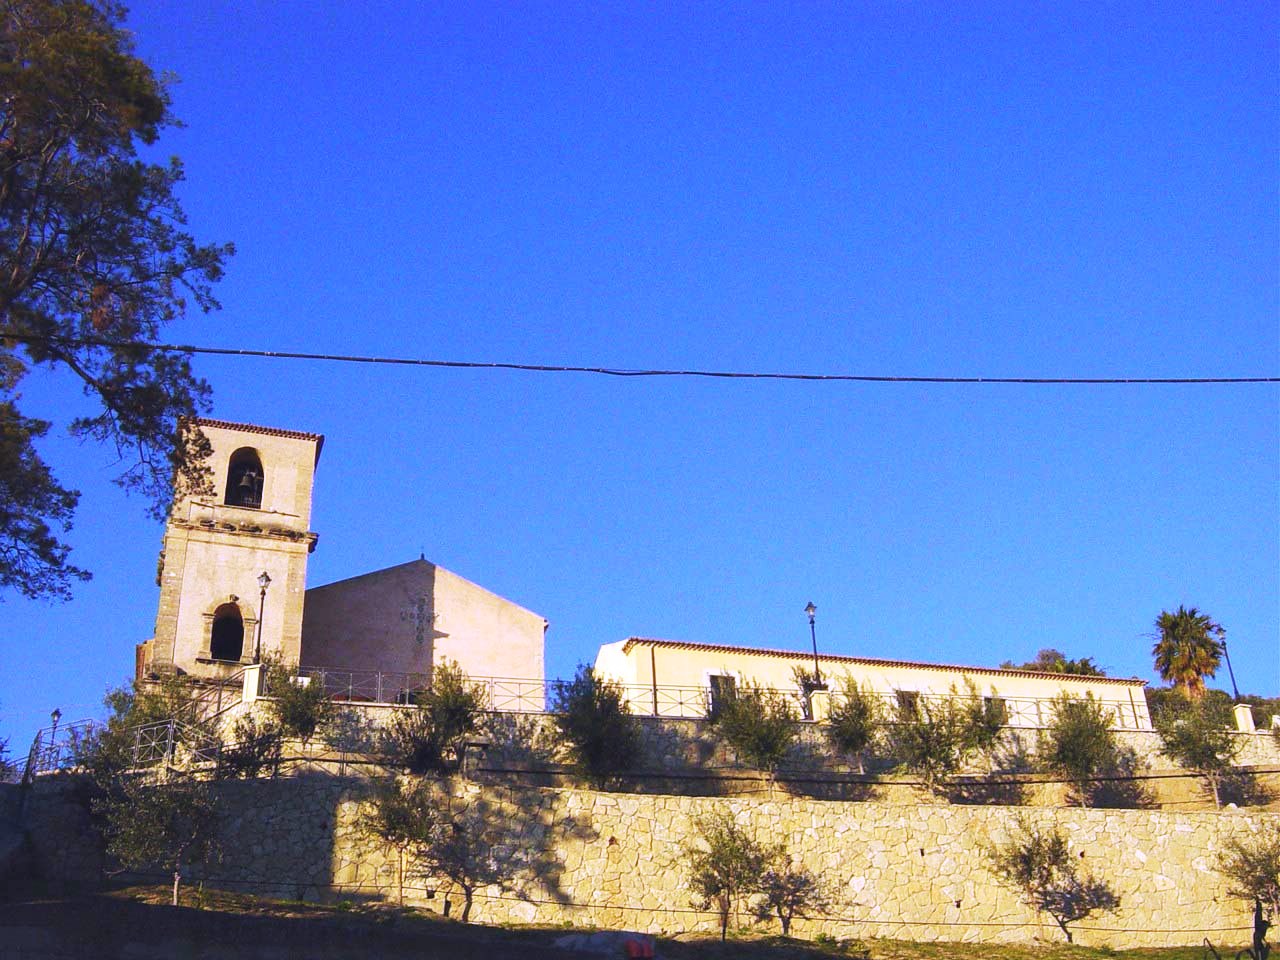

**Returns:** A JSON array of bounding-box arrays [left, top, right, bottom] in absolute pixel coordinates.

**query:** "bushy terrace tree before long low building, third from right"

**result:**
[[886, 684, 1007, 794]]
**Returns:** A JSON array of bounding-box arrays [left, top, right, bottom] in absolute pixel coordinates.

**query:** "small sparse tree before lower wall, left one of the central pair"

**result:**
[[681, 813, 782, 941]]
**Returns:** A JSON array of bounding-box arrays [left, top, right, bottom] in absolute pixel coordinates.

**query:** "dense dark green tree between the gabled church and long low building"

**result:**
[[552, 663, 640, 786]]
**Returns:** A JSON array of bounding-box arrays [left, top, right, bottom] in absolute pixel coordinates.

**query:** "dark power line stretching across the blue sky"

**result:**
[[0, 330, 1280, 385]]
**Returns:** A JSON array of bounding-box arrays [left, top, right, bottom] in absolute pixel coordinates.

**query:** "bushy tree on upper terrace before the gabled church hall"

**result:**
[[384, 660, 485, 773]]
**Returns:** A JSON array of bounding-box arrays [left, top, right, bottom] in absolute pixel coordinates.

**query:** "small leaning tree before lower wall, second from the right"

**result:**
[[987, 818, 1120, 943]]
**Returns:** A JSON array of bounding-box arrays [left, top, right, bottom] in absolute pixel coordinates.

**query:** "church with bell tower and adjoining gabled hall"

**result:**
[[137, 420, 547, 680]]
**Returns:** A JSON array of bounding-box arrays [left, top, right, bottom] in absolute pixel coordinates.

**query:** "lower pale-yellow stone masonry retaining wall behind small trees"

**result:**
[[7, 773, 1280, 947]]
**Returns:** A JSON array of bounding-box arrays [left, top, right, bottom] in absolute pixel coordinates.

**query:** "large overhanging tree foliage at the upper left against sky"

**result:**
[[0, 0, 233, 598]]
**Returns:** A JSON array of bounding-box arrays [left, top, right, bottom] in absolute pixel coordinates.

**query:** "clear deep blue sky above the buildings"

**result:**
[[0, 1, 1280, 753]]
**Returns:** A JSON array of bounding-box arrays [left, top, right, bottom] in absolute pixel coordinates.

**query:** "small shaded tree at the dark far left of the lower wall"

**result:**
[[95, 778, 219, 906]]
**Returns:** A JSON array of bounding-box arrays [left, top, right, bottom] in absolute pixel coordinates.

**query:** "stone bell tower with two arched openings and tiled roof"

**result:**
[[138, 420, 324, 680]]
